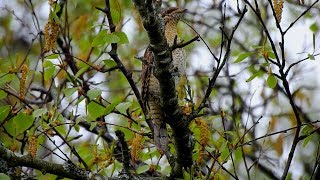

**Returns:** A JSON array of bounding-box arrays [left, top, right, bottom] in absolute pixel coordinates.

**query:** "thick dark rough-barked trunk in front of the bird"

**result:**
[[133, 0, 192, 177]]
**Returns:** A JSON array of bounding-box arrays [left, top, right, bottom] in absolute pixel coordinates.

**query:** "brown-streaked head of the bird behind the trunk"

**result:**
[[161, 7, 187, 24]]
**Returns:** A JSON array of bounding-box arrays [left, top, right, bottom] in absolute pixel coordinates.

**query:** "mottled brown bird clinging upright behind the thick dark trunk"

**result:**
[[141, 7, 187, 154]]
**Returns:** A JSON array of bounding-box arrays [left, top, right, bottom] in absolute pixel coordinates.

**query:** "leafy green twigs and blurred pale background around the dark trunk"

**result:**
[[0, 0, 320, 179]]
